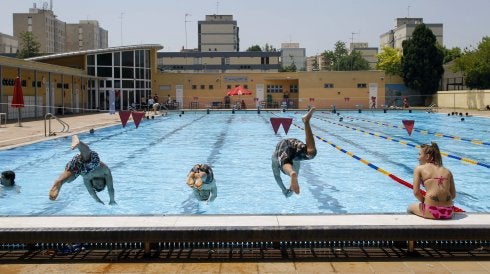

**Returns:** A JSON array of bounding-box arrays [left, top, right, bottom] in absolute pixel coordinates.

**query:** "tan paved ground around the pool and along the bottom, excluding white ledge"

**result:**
[[0, 109, 490, 274]]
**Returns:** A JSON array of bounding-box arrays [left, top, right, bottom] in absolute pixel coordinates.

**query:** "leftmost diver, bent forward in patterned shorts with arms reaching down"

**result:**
[[49, 135, 116, 205]]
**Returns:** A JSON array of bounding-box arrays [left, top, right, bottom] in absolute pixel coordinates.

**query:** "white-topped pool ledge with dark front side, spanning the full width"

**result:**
[[0, 213, 490, 253]]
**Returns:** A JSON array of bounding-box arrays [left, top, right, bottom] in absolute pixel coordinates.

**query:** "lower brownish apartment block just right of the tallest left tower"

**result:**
[[65, 20, 109, 51]]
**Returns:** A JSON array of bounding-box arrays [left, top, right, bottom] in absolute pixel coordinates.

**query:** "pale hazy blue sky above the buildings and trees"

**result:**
[[0, 0, 490, 55]]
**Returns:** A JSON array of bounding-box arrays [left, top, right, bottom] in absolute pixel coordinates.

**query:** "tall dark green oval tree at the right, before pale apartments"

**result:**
[[402, 24, 444, 95]]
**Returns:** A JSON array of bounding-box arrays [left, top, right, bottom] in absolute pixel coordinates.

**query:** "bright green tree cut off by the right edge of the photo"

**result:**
[[454, 36, 490, 89]]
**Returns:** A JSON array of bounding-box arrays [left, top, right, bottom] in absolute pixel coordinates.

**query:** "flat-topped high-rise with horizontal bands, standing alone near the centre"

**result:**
[[197, 15, 240, 52]]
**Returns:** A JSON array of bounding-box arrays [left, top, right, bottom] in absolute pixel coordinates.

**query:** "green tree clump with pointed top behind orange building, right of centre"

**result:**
[[322, 41, 369, 71]]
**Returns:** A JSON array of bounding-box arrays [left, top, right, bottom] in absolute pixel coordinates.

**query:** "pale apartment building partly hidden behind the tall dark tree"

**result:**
[[379, 18, 443, 49]]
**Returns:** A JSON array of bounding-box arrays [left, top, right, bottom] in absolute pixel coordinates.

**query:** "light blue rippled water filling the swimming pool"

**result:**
[[0, 110, 490, 215]]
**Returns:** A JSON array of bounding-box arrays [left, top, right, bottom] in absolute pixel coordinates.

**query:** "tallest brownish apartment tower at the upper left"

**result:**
[[13, 4, 66, 53]]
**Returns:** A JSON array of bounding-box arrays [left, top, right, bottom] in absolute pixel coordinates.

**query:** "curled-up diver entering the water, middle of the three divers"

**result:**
[[187, 164, 218, 202]]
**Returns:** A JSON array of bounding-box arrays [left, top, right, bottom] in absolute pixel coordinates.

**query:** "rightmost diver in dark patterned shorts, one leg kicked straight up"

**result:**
[[272, 107, 317, 197]]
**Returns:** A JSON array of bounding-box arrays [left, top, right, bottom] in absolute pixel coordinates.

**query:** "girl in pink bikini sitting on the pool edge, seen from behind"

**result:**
[[408, 143, 456, 219]]
